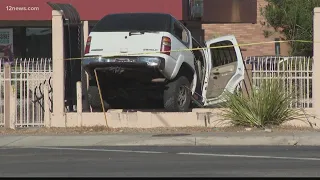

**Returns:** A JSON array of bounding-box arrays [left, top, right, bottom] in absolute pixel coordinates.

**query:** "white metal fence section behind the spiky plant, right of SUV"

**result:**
[[245, 57, 313, 108]]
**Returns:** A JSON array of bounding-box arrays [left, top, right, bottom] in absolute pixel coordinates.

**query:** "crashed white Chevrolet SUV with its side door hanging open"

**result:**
[[82, 13, 244, 112]]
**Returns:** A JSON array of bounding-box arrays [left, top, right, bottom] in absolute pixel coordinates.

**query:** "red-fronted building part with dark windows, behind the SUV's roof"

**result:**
[[0, 0, 185, 58]]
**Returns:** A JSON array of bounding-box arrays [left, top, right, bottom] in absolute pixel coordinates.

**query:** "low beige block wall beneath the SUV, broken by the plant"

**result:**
[[58, 109, 320, 129]]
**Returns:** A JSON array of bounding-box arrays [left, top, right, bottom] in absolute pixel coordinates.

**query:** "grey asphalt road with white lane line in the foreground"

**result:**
[[0, 146, 320, 177]]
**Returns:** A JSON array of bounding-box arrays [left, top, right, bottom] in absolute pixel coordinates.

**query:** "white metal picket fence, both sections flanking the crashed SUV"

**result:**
[[0, 57, 313, 127]]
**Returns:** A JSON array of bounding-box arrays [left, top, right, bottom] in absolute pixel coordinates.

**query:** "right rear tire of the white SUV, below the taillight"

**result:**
[[163, 76, 191, 112]]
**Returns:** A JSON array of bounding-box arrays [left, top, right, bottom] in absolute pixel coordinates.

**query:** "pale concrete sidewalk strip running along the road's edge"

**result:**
[[0, 132, 320, 147]]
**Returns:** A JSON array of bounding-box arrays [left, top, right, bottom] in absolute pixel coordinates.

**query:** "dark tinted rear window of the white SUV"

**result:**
[[92, 13, 171, 32]]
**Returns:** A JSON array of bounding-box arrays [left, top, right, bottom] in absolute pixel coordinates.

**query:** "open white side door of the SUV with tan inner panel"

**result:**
[[202, 35, 245, 106]]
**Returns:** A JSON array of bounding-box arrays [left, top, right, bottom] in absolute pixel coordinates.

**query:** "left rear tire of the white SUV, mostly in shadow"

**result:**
[[88, 86, 109, 112]]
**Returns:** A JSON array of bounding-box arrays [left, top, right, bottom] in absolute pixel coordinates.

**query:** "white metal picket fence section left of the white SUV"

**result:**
[[0, 58, 52, 127]]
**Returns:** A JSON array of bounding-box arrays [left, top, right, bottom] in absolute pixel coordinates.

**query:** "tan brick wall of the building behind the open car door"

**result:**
[[202, 0, 290, 56]]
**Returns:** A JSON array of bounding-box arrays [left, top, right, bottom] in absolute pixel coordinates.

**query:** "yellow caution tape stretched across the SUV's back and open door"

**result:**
[[65, 40, 314, 60]]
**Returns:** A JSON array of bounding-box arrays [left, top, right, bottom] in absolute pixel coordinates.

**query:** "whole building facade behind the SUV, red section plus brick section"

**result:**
[[0, 0, 287, 58]]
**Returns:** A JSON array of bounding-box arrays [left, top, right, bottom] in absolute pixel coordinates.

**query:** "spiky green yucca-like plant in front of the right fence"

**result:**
[[222, 80, 304, 128]]
